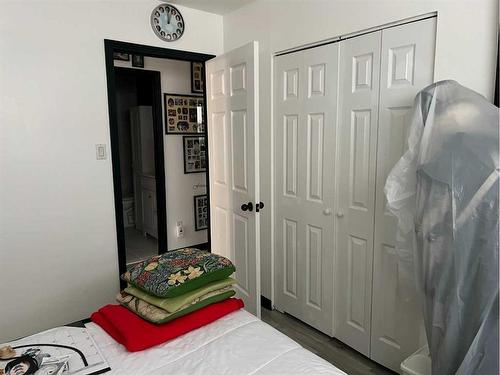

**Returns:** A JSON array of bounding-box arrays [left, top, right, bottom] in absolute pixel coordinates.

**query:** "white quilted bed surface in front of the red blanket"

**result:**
[[86, 310, 345, 375]]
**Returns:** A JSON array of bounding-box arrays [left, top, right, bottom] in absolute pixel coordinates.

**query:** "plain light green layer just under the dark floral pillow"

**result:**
[[125, 277, 236, 313]]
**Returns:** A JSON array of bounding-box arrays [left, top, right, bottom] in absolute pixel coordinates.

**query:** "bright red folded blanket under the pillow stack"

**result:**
[[91, 298, 243, 352]]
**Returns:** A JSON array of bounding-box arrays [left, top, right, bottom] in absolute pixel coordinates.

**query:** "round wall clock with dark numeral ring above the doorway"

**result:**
[[151, 4, 185, 42]]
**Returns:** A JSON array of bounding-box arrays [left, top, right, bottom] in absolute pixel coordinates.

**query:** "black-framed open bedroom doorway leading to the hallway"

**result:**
[[104, 40, 213, 284]]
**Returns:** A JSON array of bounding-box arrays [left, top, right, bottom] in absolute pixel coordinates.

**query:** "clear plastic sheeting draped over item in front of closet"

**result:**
[[385, 81, 499, 375]]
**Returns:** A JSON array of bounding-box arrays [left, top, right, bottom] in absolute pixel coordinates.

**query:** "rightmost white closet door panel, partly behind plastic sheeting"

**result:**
[[371, 18, 436, 371]]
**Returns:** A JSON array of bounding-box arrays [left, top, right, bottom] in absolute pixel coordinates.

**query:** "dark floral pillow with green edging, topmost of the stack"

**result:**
[[122, 248, 235, 298]]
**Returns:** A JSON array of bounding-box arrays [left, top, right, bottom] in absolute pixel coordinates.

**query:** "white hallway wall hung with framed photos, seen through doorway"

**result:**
[[115, 57, 207, 250]]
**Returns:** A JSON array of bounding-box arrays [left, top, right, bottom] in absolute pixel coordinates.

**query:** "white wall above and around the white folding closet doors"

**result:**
[[224, 0, 498, 298]]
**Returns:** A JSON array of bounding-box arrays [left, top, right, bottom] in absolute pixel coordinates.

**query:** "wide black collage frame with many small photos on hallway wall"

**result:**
[[164, 94, 205, 134]]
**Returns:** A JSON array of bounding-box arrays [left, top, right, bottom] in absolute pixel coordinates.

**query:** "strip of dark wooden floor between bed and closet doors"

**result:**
[[262, 308, 395, 375]]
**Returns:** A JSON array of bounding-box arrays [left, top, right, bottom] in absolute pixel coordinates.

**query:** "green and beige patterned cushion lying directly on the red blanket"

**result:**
[[116, 286, 236, 324]]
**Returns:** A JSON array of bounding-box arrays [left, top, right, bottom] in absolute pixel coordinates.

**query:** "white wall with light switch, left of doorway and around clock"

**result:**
[[0, 0, 223, 342]]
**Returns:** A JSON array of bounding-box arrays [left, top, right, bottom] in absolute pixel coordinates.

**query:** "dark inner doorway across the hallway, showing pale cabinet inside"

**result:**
[[115, 69, 161, 264]]
